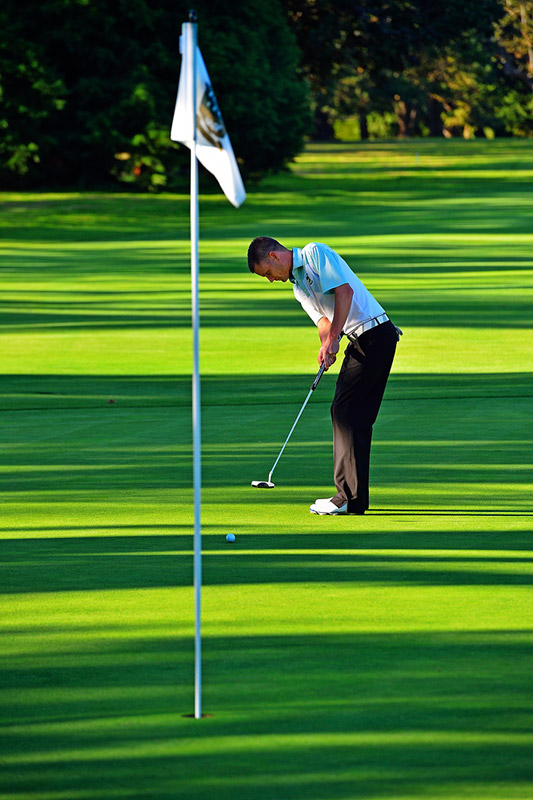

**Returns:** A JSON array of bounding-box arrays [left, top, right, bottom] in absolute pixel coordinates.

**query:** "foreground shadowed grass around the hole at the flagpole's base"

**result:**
[[2, 625, 531, 800]]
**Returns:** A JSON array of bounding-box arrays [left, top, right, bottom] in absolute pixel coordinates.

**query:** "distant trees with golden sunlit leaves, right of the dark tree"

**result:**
[[283, 0, 533, 139]]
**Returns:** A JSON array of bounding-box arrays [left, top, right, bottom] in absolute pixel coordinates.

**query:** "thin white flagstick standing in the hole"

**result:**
[[187, 12, 202, 719]]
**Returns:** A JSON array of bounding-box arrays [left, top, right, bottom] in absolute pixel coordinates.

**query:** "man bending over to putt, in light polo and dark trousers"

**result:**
[[248, 236, 401, 514]]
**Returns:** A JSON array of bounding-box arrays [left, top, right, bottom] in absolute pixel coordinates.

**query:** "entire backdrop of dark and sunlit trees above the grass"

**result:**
[[0, 0, 533, 190]]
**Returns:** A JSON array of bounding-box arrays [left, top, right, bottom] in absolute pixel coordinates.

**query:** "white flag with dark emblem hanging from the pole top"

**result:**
[[170, 36, 246, 207]]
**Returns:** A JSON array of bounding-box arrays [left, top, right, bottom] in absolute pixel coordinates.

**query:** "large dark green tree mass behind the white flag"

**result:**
[[0, 0, 308, 189]]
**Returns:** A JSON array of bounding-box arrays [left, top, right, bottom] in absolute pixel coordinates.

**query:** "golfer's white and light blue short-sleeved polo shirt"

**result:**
[[292, 242, 385, 334]]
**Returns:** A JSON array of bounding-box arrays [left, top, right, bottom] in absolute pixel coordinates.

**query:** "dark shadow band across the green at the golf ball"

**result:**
[[0, 526, 533, 593]]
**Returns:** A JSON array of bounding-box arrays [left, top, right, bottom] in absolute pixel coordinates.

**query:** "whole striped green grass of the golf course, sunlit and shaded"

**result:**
[[0, 140, 533, 800]]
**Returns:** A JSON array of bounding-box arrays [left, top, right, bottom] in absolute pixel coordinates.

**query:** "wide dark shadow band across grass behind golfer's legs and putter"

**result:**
[[0, 373, 531, 512]]
